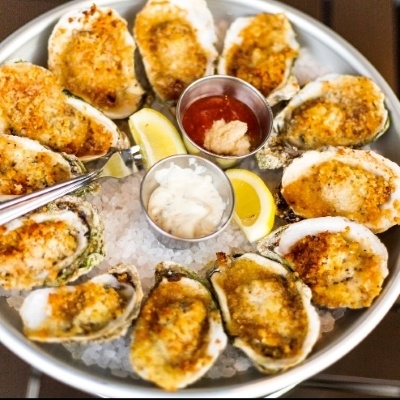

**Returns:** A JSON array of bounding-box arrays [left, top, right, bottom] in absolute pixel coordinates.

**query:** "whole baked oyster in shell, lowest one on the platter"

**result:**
[[130, 261, 227, 391]]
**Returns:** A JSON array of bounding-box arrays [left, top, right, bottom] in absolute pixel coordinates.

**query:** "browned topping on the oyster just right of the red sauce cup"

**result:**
[[280, 76, 386, 149]]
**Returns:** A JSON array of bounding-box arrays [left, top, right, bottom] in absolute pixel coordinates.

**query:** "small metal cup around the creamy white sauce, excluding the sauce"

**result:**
[[140, 154, 235, 249]]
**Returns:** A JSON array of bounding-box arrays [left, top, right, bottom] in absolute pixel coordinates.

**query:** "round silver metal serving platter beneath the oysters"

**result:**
[[0, 0, 400, 398]]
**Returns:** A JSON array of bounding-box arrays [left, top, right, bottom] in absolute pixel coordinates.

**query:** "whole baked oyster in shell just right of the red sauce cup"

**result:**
[[256, 74, 390, 169]]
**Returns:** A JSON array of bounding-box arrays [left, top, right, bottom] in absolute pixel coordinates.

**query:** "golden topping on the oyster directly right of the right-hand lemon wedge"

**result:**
[[282, 159, 395, 229]]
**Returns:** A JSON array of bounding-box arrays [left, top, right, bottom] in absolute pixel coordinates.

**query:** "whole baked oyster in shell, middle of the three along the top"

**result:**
[[133, 0, 218, 105]]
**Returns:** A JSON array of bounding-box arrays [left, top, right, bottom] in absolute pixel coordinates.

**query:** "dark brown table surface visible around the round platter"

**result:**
[[0, 0, 400, 398]]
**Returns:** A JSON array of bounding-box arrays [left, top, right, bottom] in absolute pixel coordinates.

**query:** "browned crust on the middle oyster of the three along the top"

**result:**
[[133, 2, 209, 101]]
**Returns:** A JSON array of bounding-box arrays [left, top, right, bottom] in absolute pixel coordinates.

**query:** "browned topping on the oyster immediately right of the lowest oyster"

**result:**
[[212, 258, 309, 360]]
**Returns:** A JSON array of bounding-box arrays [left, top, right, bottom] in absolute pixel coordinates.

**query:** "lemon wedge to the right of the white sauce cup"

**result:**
[[225, 168, 276, 243]]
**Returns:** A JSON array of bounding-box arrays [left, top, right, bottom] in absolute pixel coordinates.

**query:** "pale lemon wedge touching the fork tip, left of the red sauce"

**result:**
[[128, 108, 187, 169]]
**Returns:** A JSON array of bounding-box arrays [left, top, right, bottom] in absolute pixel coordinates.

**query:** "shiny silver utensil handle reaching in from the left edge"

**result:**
[[0, 171, 101, 225]]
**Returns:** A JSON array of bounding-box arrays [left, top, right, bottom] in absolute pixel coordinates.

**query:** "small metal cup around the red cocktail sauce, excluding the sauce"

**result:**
[[176, 75, 273, 169]]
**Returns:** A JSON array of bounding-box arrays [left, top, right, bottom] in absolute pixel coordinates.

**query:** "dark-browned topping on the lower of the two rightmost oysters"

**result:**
[[284, 228, 386, 308]]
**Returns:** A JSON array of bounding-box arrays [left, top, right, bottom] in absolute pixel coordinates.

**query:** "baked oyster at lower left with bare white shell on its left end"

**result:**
[[19, 264, 143, 343]]
